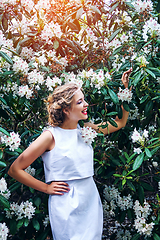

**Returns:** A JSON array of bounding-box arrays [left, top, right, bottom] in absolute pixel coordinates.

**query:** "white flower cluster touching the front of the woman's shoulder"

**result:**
[[81, 127, 97, 145]]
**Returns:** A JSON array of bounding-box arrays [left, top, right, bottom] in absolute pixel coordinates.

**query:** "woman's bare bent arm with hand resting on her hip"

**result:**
[[8, 131, 69, 195]]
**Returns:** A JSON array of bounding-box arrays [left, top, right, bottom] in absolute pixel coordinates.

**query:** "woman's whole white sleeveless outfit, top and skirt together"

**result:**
[[42, 126, 103, 240]]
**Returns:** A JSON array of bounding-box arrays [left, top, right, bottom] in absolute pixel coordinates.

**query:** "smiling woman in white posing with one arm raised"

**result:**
[[8, 67, 131, 240]]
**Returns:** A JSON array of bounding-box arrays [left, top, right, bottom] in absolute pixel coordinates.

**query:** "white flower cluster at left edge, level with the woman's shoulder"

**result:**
[[1, 132, 21, 151]]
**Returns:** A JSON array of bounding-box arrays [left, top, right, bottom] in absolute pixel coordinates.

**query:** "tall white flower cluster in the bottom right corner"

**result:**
[[134, 200, 154, 236]]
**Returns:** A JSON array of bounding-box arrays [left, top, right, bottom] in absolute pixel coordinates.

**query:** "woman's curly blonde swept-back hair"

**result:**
[[47, 83, 79, 126]]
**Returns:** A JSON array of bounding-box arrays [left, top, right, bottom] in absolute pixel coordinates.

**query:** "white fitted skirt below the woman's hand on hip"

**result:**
[[48, 177, 103, 240]]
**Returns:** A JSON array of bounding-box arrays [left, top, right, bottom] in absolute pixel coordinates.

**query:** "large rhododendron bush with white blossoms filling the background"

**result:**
[[0, 0, 160, 240]]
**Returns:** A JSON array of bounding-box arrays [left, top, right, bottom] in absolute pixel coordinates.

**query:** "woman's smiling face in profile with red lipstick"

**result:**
[[67, 90, 88, 122]]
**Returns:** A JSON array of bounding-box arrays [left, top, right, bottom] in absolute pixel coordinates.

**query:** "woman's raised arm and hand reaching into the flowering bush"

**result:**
[[84, 69, 132, 134]]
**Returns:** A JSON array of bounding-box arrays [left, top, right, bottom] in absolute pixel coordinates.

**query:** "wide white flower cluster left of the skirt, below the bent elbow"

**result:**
[[6, 201, 36, 220]]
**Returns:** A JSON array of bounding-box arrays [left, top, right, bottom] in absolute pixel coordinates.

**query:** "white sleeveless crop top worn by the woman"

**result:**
[[42, 126, 94, 183]]
